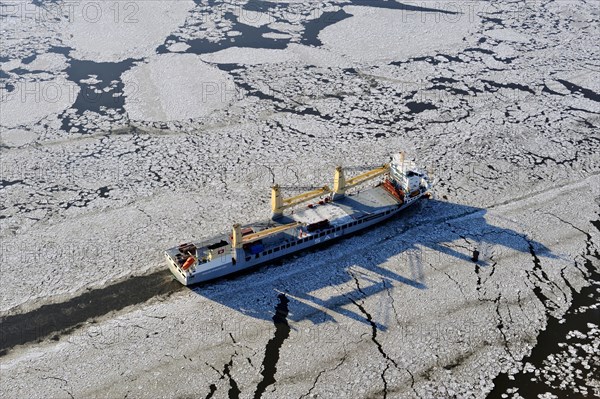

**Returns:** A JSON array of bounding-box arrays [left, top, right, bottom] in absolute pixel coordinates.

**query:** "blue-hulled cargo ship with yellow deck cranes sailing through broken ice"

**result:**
[[165, 152, 432, 285]]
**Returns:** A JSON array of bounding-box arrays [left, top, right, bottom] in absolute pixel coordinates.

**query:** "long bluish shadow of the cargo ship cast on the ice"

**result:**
[[190, 200, 556, 331]]
